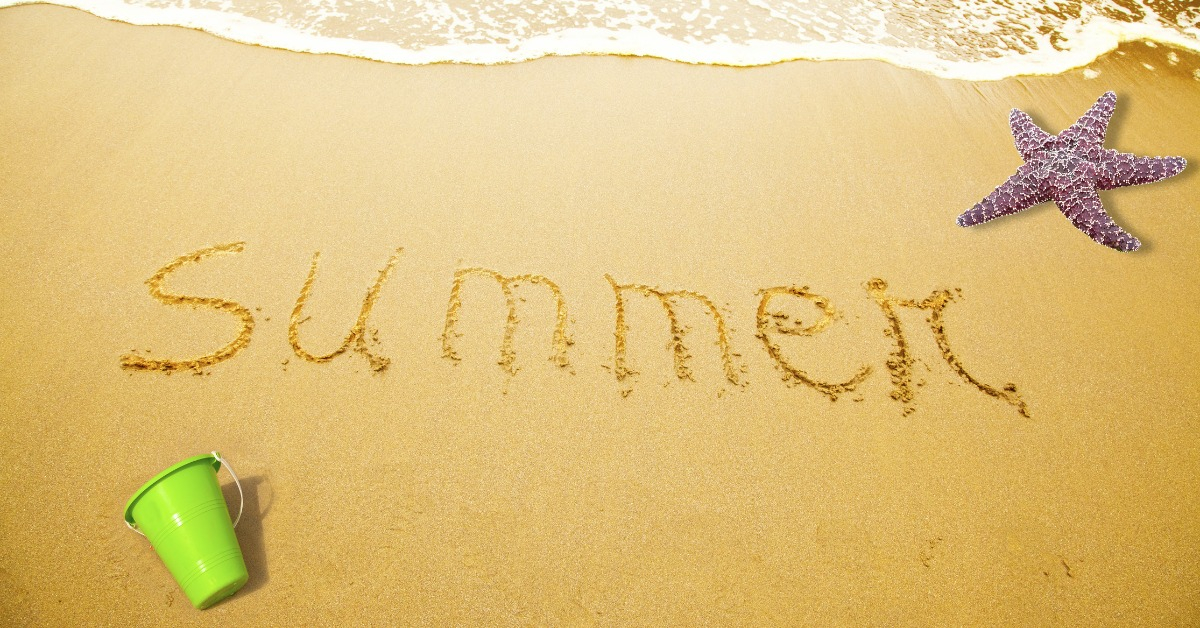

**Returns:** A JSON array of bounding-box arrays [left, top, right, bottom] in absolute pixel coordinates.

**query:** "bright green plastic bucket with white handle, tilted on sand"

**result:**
[[125, 451, 248, 609]]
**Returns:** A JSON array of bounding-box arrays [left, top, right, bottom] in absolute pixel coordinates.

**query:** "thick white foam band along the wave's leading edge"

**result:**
[[0, 0, 1200, 80]]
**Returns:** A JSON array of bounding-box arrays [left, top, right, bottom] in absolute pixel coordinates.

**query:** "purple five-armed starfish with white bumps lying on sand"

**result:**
[[959, 91, 1188, 251]]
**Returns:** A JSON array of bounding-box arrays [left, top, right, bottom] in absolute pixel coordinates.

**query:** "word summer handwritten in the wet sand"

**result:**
[[121, 243, 1028, 417]]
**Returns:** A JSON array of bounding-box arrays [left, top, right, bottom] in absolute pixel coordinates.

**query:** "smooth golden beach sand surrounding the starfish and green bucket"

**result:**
[[0, 6, 1200, 626]]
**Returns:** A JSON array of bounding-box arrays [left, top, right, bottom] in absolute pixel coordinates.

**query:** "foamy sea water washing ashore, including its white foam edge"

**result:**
[[0, 0, 1200, 80]]
